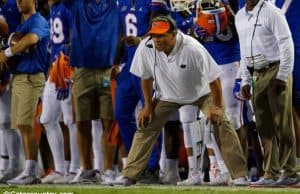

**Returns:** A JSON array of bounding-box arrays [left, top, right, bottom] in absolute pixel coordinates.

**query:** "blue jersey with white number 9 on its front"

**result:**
[[50, 3, 72, 62]]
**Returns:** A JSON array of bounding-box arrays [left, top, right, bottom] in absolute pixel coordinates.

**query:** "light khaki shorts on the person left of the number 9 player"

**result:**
[[11, 73, 45, 129]]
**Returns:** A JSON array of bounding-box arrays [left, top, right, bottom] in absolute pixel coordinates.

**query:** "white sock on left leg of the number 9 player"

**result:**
[[44, 122, 65, 174]]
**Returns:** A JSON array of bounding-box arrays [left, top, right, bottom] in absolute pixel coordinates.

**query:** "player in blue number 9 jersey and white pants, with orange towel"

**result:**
[[40, 0, 80, 183]]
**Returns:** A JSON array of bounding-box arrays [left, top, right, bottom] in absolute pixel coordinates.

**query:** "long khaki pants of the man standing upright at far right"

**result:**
[[252, 65, 296, 179]]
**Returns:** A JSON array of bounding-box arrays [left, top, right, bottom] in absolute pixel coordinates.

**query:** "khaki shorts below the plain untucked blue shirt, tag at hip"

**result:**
[[72, 68, 113, 121]]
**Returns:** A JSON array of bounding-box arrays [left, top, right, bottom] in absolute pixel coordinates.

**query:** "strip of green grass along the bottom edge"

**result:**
[[0, 185, 300, 194]]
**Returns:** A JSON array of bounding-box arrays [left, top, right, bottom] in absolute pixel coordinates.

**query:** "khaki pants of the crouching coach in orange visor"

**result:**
[[122, 95, 247, 180]]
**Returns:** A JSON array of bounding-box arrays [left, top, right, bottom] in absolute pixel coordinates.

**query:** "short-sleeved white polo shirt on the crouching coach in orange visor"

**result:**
[[130, 31, 221, 104]]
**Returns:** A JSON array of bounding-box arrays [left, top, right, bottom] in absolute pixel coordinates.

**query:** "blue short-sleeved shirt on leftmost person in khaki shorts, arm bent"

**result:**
[[14, 13, 50, 74]]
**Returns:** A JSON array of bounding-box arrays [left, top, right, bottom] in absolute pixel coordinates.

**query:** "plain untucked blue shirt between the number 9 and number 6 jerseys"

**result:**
[[65, 0, 119, 69]]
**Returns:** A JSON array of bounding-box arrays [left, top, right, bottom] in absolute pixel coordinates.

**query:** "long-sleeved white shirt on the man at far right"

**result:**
[[235, 0, 294, 85]]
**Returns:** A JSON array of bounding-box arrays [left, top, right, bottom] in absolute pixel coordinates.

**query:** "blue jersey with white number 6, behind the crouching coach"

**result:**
[[118, 0, 151, 71]]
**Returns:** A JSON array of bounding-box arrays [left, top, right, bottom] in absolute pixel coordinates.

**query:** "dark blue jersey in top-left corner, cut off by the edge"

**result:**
[[0, 0, 21, 33]]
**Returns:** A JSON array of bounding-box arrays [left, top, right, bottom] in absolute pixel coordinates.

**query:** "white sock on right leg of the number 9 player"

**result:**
[[68, 123, 80, 172]]
